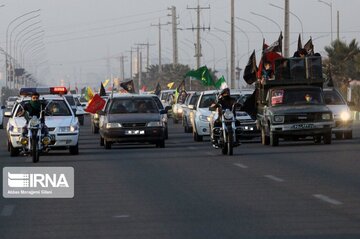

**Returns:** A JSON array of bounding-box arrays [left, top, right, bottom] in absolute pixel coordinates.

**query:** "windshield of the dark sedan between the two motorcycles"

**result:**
[[109, 98, 159, 114]]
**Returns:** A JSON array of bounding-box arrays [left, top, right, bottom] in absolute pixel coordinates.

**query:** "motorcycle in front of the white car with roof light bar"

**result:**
[[20, 101, 51, 163]]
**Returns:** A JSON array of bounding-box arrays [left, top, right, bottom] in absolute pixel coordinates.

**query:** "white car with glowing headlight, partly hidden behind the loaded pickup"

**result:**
[[323, 88, 353, 139]]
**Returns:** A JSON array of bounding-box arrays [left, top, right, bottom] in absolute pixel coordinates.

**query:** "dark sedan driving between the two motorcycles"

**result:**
[[98, 95, 166, 149]]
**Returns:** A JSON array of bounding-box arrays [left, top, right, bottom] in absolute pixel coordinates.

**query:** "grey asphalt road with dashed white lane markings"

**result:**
[[0, 115, 360, 239]]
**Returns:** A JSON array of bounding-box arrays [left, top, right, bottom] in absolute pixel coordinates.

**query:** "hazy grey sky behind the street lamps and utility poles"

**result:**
[[0, 0, 360, 86]]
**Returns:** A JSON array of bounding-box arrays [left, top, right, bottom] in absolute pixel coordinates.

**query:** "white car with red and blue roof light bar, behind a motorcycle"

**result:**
[[5, 88, 79, 156]]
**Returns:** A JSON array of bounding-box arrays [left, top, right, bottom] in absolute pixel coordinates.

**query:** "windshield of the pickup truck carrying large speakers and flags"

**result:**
[[269, 89, 323, 106]]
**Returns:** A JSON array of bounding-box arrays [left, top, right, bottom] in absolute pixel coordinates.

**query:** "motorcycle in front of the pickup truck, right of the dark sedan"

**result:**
[[209, 96, 241, 155]]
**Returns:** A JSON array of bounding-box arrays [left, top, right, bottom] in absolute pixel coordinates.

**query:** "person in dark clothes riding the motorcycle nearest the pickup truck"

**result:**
[[210, 88, 240, 147]]
